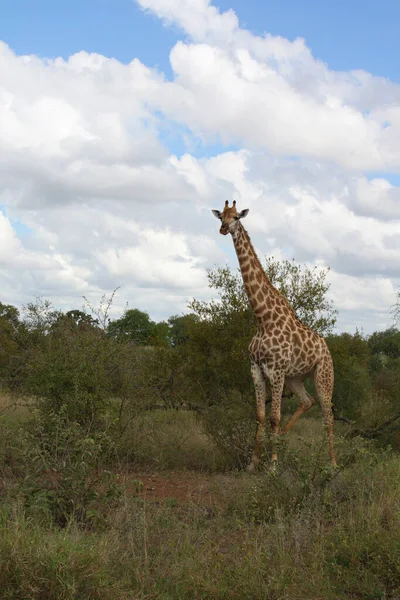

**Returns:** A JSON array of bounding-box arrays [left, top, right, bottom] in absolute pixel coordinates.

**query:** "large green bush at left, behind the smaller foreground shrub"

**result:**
[[8, 302, 126, 428]]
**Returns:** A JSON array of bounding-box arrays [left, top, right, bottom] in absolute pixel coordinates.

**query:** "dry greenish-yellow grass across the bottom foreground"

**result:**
[[0, 450, 400, 600]]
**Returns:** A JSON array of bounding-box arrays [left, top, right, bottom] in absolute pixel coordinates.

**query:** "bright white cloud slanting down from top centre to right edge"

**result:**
[[138, 0, 400, 170]]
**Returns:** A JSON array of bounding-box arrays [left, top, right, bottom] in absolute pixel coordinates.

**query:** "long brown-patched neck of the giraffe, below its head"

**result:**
[[232, 223, 279, 324]]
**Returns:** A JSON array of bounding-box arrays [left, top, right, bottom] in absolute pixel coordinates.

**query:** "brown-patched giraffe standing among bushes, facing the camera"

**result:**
[[212, 200, 337, 471]]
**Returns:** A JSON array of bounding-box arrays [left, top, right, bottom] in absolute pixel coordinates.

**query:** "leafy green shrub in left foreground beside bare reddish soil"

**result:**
[[20, 410, 119, 526]]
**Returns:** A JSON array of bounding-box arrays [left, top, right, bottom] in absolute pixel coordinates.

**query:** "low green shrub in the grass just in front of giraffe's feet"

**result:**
[[230, 428, 391, 523]]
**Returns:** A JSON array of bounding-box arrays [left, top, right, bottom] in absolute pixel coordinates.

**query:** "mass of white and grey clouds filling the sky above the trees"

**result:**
[[0, 0, 400, 331]]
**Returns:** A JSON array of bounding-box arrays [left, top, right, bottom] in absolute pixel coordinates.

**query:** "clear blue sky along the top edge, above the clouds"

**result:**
[[0, 0, 400, 82]]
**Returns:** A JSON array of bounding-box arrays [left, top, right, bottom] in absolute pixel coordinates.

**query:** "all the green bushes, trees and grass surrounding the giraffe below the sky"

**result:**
[[0, 259, 400, 600]]
